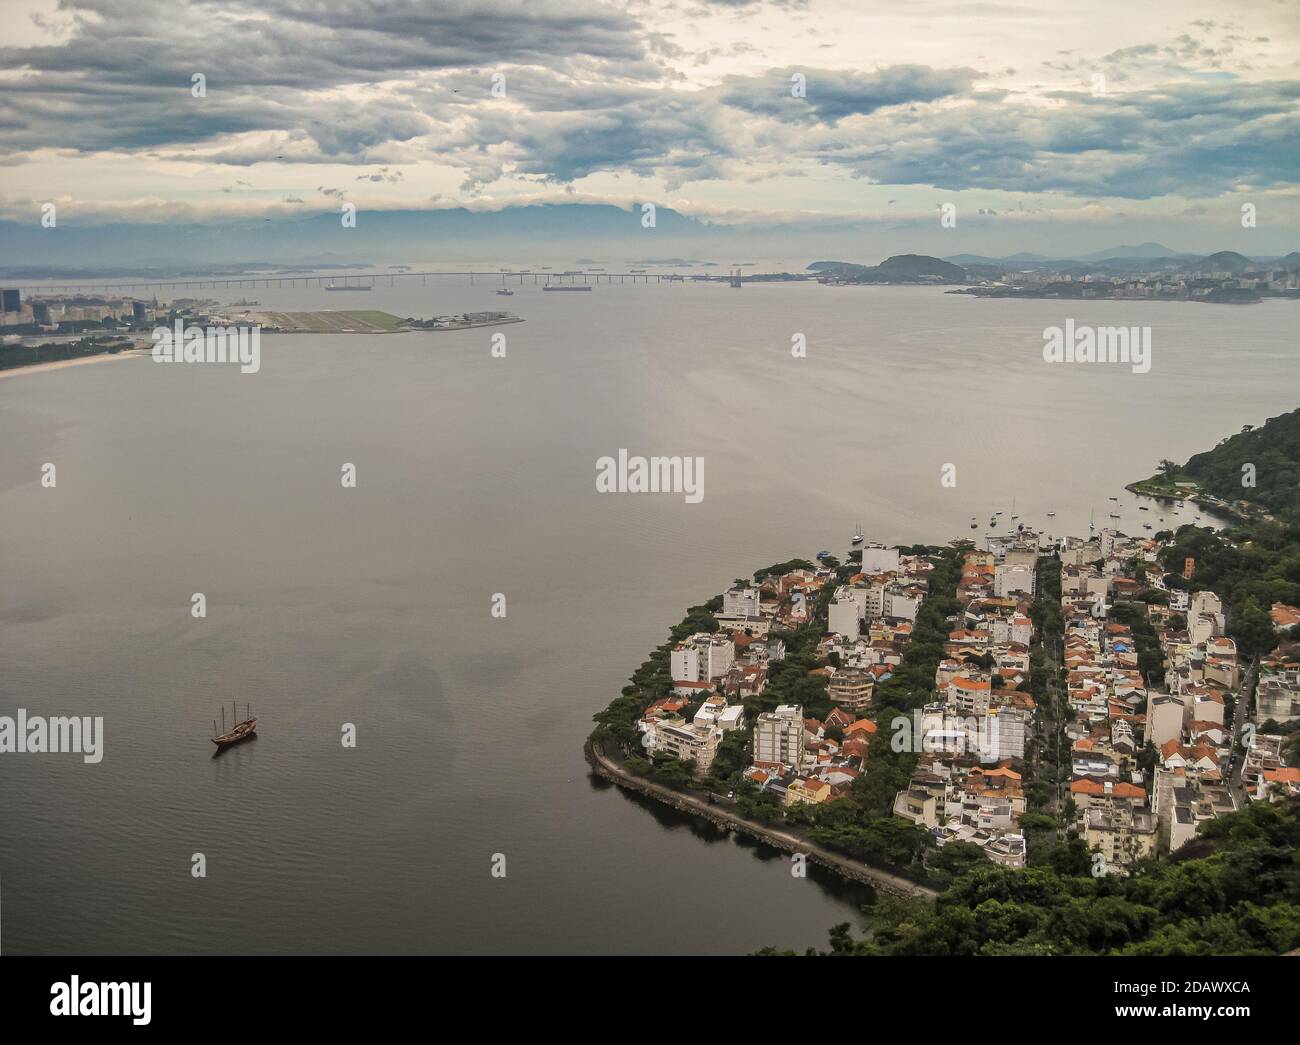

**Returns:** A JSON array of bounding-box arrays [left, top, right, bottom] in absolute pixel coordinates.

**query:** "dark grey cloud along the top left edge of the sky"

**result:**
[[0, 0, 645, 90]]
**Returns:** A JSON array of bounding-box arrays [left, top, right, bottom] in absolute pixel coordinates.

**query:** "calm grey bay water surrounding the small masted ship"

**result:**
[[0, 283, 1296, 953]]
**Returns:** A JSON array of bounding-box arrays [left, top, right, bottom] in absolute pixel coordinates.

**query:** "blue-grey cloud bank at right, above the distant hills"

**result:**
[[826, 82, 1300, 199]]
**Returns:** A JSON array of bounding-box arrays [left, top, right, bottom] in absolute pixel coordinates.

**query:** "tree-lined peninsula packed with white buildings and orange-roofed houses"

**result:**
[[585, 411, 1300, 954]]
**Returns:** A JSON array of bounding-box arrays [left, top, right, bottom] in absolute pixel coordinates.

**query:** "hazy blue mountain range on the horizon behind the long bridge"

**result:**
[[0, 203, 1300, 281]]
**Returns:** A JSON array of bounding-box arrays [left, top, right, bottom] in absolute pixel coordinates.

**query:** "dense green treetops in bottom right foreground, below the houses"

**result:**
[[769, 802, 1300, 955]]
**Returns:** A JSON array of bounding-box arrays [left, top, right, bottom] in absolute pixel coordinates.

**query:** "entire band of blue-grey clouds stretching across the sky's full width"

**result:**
[[0, 0, 1300, 199]]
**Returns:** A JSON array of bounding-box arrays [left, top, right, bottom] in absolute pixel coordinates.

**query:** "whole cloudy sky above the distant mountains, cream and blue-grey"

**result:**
[[0, 0, 1300, 252]]
